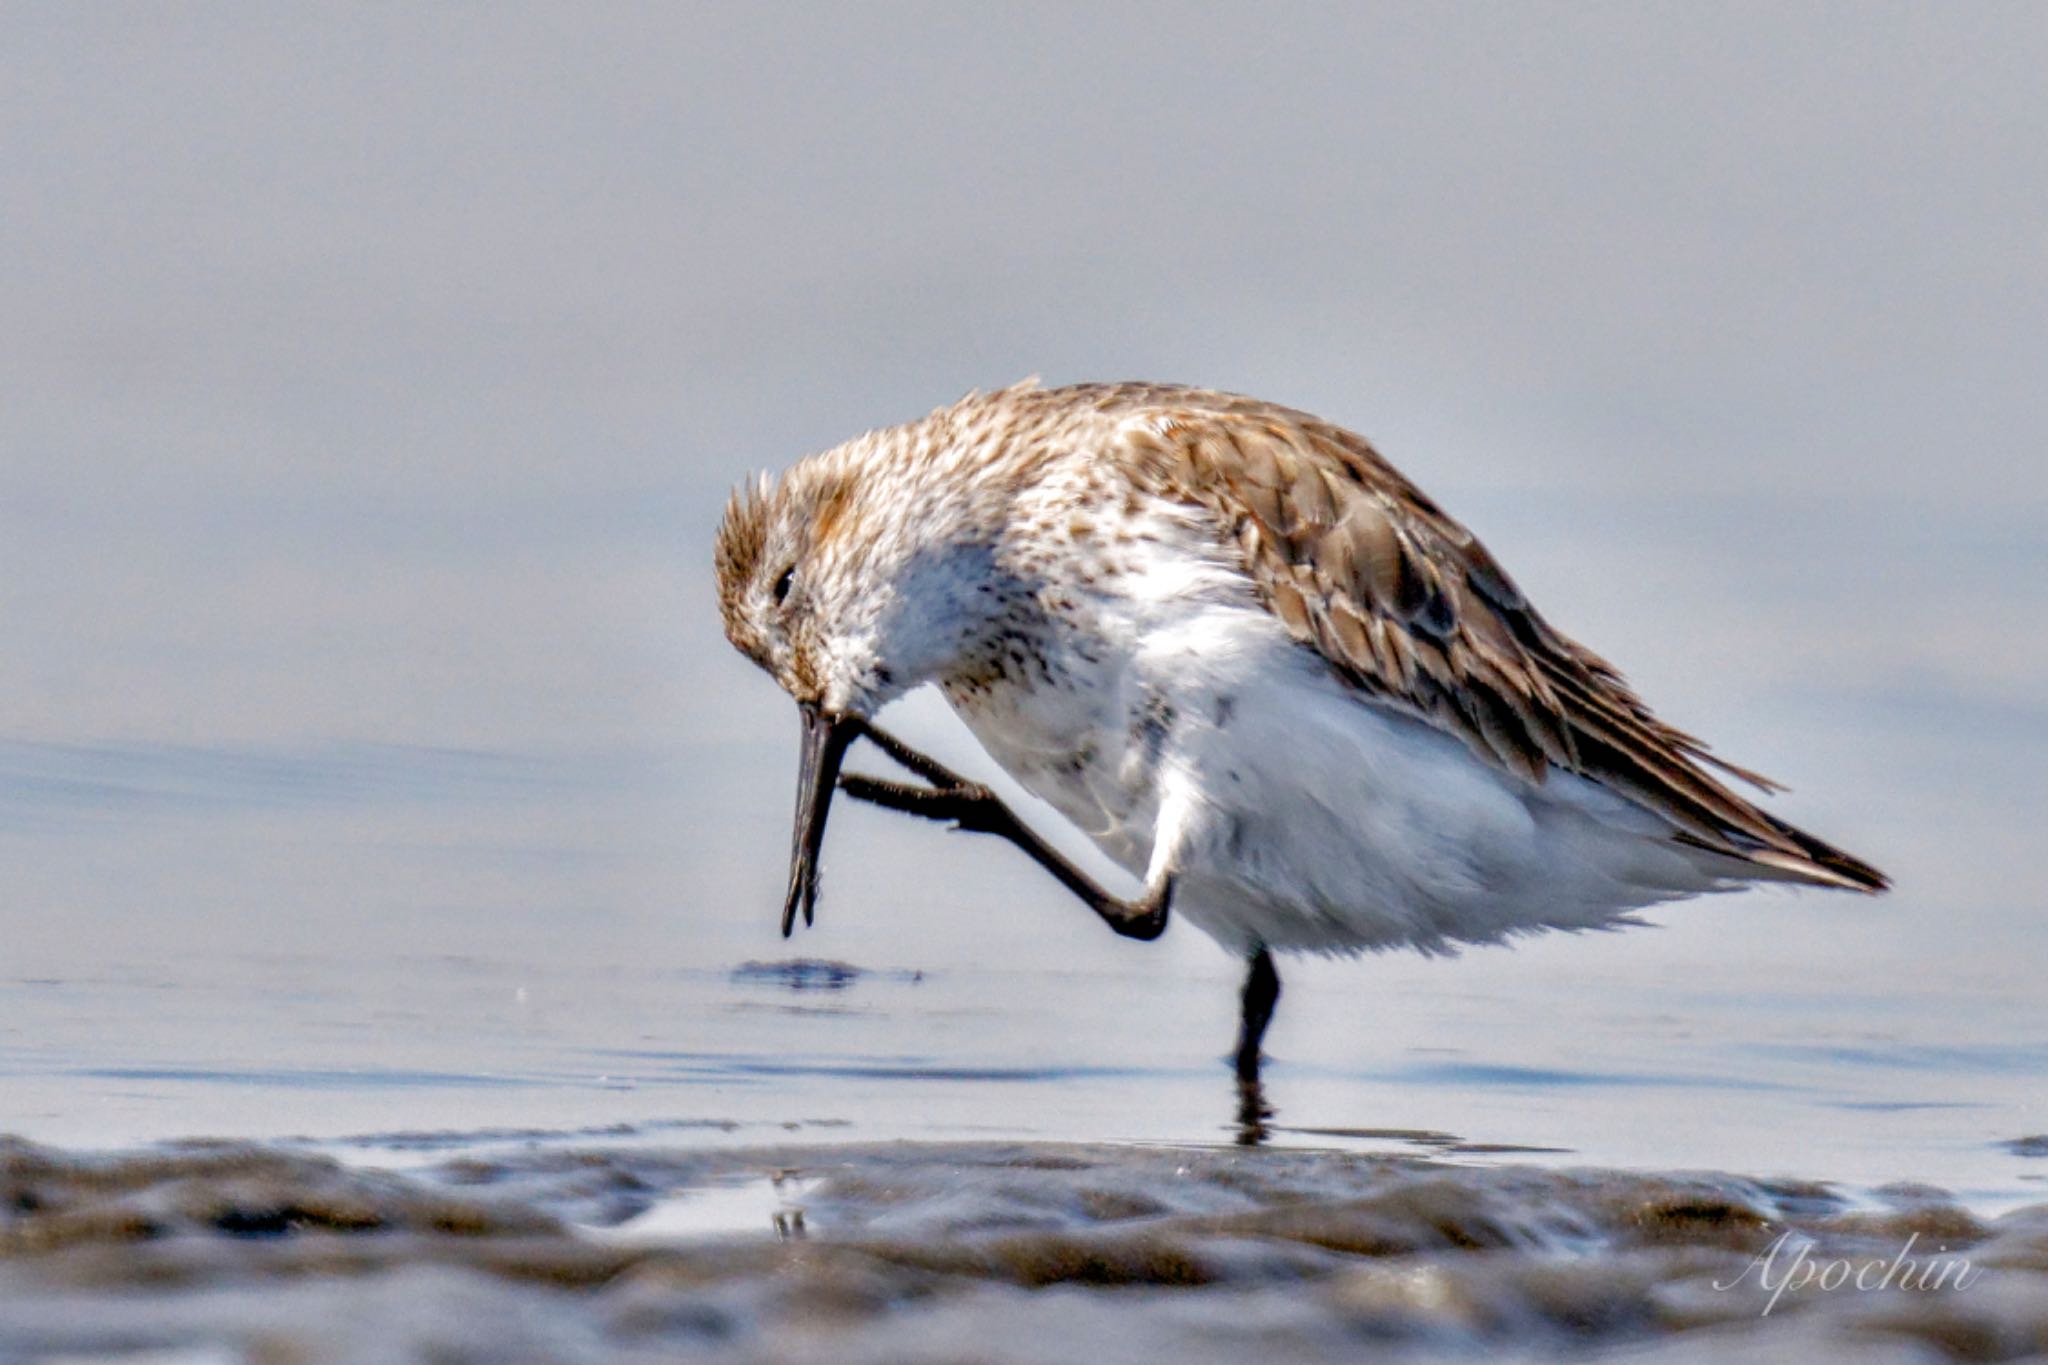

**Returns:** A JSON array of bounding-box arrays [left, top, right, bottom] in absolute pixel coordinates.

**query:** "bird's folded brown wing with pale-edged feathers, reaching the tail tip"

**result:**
[[1073, 385, 1886, 890]]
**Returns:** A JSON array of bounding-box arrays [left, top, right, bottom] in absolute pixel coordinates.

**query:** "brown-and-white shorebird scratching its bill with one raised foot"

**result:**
[[717, 385, 1886, 1078]]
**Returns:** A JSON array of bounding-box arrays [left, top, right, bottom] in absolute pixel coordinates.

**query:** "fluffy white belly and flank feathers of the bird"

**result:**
[[950, 596, 1722, 954]]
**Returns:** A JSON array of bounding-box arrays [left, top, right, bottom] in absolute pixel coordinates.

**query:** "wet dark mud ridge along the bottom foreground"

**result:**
[[0, 1140, 2048, 1365]]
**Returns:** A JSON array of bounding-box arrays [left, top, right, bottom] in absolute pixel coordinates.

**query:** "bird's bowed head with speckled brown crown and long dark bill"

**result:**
[[717, 434, 1001, 935]]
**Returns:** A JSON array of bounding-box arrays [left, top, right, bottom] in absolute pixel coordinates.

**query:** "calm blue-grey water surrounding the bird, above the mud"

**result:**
[[0, 6, 2048, 1203]]
